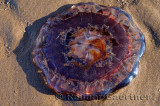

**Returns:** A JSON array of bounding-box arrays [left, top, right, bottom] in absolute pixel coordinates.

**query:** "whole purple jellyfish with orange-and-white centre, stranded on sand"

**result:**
[[33, 3, 145, 100]]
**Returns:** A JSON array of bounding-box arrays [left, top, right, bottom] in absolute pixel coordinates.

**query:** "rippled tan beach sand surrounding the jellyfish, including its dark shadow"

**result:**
[[0, 0, 160, 106]]
